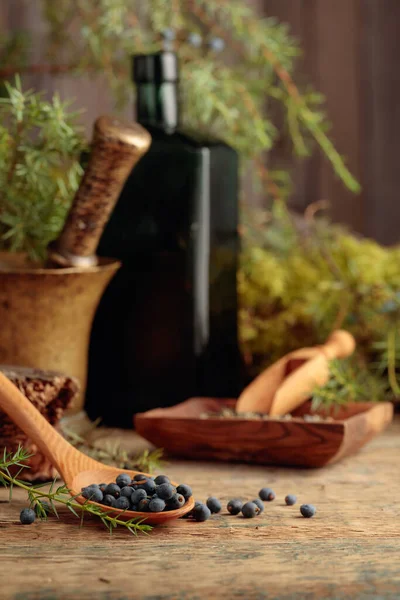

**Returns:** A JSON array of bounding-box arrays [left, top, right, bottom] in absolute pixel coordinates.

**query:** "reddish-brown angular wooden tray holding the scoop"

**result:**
[[135, 398, 393, 467]]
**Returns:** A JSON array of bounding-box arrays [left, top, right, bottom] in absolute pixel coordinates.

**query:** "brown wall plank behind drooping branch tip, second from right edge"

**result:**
[[315, 0, 364, 231]]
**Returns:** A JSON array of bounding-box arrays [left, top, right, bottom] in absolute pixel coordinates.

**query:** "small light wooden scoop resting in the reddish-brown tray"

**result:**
[[236, 330, 355, 416]]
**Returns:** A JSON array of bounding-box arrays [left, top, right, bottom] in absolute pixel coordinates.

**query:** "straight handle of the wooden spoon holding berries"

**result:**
[[0, 372, 80, 475]]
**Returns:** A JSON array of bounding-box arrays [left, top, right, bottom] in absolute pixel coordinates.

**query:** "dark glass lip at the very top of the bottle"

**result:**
[[132, 50, 179, 83]]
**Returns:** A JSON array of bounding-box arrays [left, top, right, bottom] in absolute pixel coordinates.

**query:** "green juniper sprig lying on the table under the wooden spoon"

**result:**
[[0, 447, 152, 535]]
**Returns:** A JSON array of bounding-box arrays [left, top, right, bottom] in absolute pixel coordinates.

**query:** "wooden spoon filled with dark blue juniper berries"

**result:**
[[0, 373, 194, 525]]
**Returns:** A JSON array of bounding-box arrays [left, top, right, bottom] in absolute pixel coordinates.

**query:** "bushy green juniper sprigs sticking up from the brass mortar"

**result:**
[[0, 77, 84, 258]]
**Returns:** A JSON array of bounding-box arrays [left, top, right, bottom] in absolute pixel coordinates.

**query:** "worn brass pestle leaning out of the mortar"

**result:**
[[49, 116, 151, 268]]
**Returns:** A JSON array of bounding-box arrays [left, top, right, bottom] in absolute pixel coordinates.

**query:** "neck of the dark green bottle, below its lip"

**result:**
[[136, 82, 179, 131]]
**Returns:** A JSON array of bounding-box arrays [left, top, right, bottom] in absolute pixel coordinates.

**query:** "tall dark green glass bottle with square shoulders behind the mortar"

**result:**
[[86, 51, 243, 427]]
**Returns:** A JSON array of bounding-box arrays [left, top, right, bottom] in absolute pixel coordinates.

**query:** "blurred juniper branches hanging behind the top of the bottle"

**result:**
[[34, 0, 359, 191]]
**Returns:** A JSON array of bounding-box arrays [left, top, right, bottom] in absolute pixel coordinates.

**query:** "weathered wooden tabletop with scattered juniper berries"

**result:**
[[0, 417, 400, 600]]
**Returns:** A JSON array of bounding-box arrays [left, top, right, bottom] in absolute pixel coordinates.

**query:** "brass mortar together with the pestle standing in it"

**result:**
[[0, 116, 151, 412]]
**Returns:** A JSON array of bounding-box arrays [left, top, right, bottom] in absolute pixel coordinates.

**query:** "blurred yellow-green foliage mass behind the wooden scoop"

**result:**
[[239, 203, 400, 402]]
